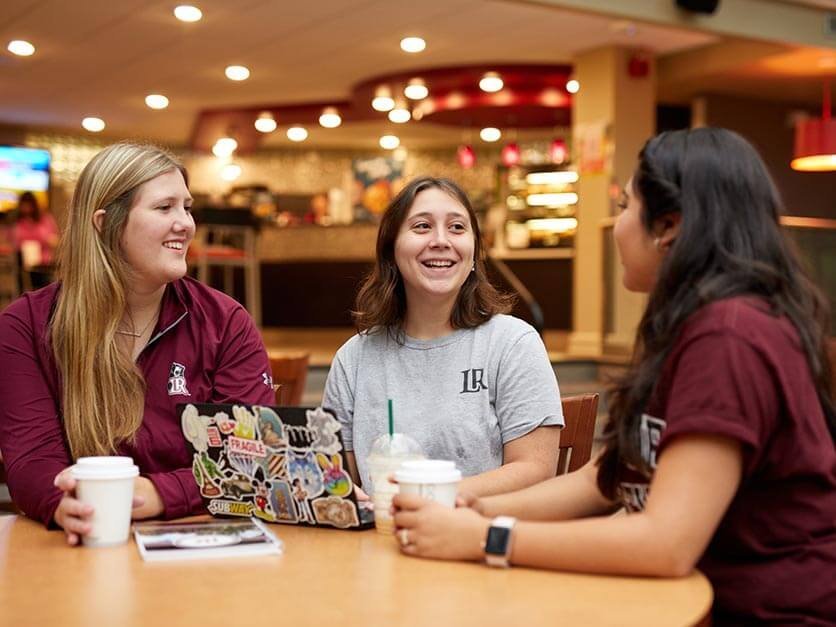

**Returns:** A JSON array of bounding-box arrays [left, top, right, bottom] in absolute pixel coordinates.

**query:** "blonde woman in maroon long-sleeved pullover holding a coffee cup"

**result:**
[[0, 143, 273, 544]]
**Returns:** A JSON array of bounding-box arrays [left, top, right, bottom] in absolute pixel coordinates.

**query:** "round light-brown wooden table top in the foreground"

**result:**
[[0, 516, 712, 627]]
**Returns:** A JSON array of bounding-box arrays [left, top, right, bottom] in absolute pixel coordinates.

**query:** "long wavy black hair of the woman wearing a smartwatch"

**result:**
[[598, 128, 836, 498]]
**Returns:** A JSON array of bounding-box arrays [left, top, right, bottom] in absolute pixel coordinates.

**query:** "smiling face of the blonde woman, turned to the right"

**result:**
[[121, 169, 195, 291]]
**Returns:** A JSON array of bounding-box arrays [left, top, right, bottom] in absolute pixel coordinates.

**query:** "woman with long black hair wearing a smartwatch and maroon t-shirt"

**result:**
[[395, 128, 836, 625]]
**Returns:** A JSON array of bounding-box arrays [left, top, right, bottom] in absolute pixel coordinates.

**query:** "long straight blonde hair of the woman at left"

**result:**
[[50, 143, 186, 459]]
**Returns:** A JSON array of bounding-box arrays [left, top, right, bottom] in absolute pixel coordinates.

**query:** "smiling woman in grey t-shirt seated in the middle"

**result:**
[[323, 177, 563, 495]]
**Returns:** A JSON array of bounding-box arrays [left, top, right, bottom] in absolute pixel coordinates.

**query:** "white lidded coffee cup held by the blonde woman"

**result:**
[[71, 456, 139, 546]]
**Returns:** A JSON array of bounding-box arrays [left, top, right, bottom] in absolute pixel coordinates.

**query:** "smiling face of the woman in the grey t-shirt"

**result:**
[[395, 187, 475, 304]]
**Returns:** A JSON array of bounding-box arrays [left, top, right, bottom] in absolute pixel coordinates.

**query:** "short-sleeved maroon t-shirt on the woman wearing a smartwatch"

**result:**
[[619, 297, 836, 625]]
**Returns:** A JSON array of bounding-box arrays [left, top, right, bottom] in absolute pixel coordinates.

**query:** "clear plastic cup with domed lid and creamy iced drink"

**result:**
[[366, 433, 424, 534]]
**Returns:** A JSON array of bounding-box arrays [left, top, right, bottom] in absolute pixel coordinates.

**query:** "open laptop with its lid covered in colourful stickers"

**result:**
[[177, 403, 374, 529]]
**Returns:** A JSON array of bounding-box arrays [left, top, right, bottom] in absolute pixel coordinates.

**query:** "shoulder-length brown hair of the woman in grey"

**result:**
[[352, 176, 513, 334]]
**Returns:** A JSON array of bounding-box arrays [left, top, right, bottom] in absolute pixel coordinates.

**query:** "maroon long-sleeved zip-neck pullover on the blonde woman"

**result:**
[[0, 278, 275, 524]]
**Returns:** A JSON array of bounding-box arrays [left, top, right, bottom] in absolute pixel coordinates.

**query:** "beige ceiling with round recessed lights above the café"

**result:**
[[0, 0, 824, 143]]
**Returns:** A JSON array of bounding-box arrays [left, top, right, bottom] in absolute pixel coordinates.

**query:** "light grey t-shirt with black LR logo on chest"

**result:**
[[322, 315, 563, 486]]
